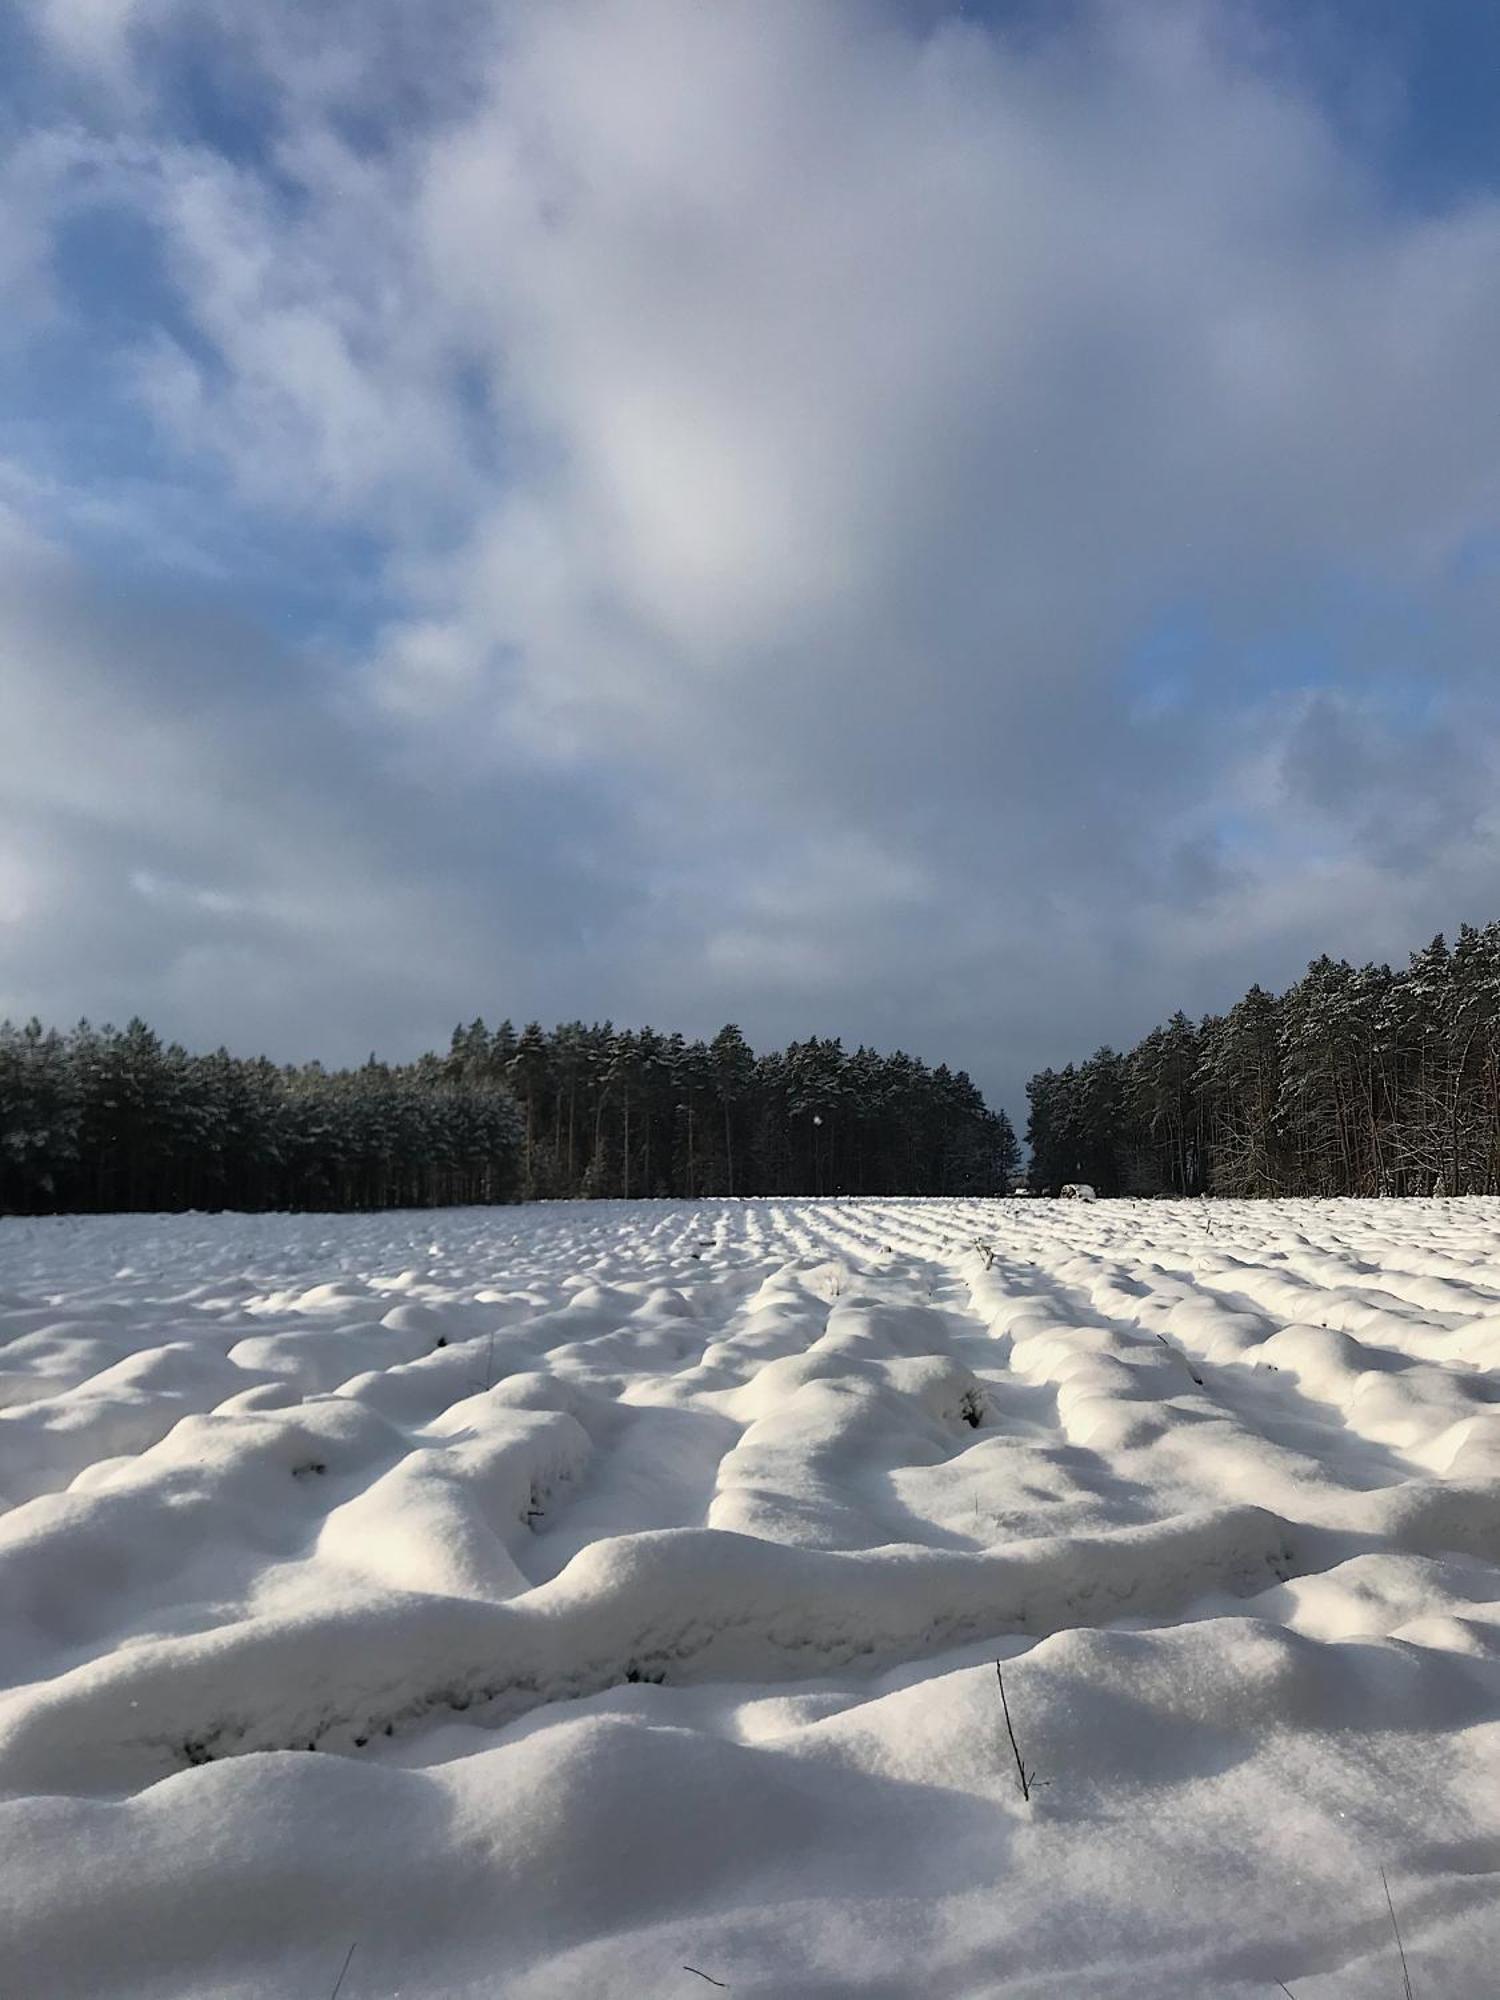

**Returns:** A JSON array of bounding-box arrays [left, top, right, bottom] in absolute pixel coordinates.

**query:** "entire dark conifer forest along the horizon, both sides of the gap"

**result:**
[[11, 922, 1500, 1214]]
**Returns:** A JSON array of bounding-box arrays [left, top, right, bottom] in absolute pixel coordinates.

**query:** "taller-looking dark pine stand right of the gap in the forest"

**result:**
[[1026, 922, 1500, 1196]]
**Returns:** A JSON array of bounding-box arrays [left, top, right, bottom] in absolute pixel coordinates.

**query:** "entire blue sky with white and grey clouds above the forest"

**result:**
[[0, 0, 1500, 1112]]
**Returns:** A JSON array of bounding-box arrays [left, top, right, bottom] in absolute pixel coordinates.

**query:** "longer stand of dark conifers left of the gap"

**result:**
[[0, 1020, 1018, 1214]]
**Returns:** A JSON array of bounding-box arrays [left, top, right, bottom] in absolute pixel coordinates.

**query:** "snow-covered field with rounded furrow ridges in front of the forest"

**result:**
[[0, 1202, 1500, 2000]]
